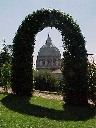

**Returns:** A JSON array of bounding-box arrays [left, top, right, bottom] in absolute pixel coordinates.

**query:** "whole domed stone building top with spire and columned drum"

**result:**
[[36, 34, 61, 71]]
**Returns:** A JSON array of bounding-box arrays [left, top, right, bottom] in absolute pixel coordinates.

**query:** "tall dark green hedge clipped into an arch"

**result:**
[[12, 9, 87, 104]]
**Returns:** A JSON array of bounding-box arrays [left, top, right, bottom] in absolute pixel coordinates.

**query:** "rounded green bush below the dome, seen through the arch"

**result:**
[[34, 70, 60, 92]]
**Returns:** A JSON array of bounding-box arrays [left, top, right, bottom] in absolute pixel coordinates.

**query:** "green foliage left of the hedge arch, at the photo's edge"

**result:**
[[0, 44, 12, 91]]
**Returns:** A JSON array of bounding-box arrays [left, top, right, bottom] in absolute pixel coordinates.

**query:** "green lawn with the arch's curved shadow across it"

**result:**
[[0, 94, 96, 128]]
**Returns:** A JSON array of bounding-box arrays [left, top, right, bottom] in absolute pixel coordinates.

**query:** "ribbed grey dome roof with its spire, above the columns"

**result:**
[[38, 34, 61, 56]]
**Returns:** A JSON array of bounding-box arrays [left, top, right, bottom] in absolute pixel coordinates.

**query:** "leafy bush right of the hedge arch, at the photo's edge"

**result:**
[[88, 63, 96, 105]]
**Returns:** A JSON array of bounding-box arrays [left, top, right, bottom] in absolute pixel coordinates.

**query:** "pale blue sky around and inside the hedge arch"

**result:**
[[0, 0, 96, 65]]
